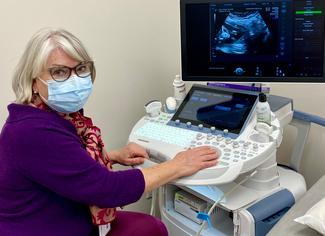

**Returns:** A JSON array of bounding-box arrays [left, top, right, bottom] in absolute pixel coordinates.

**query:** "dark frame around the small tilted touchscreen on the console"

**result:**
[[171, 85, 259, 138]]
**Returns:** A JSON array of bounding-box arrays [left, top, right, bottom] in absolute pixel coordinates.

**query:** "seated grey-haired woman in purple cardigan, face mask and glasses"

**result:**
[[0, 29, 217, 236]]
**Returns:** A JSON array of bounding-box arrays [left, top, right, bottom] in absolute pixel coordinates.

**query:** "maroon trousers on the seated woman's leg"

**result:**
[[108, 211, 168, 236]]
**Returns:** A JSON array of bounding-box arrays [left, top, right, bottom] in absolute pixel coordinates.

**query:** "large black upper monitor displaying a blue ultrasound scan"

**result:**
[[180, 0, 325, 83]]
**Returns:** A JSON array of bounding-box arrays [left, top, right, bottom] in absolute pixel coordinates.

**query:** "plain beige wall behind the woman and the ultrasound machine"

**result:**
[[0, 0, 325, 214]]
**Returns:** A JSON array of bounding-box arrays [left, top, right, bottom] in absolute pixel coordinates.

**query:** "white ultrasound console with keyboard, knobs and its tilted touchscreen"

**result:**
[[129, 86, 282, 185]]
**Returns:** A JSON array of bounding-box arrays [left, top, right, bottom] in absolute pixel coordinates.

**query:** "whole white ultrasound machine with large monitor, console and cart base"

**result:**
[[129, 0, 325, 236]]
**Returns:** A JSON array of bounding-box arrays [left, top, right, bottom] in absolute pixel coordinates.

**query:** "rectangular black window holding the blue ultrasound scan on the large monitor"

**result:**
[[211, 6, 278, 59]]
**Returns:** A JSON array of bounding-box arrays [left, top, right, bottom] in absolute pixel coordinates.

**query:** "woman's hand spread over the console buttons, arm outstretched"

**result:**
[[172, 146, 219, 177]]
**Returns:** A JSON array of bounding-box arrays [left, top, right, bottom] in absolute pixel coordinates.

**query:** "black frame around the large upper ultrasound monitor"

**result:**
[[180, 0, 325, 83]]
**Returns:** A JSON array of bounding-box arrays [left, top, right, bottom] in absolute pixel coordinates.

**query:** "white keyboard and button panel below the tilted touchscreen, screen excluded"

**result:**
[[129, 113, 281, 185]]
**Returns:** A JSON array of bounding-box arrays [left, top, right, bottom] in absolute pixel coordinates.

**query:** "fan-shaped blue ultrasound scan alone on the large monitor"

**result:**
[[213, 11, 273, 54]]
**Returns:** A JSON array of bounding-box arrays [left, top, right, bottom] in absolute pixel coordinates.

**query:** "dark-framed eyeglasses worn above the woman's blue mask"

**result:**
[[48, 61, 94, 82]]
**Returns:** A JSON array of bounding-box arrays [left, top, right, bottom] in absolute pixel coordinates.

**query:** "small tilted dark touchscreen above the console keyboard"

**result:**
[[172, 85, 258, 134]]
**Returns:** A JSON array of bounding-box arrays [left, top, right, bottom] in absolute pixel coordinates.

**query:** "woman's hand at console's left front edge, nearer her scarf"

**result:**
[[108, 143, 149, 166]]
